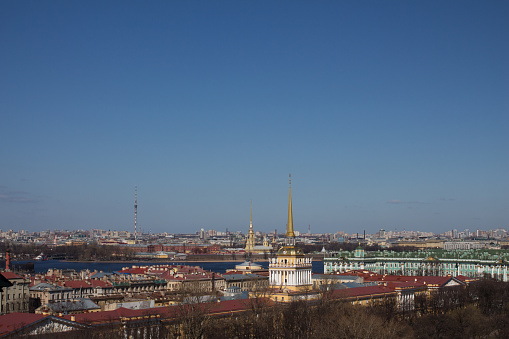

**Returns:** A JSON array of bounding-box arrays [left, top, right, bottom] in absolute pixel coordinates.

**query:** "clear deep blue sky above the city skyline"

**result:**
[[0, 0, 509, 233]]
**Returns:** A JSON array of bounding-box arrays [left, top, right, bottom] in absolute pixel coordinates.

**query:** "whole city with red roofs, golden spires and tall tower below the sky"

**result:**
[[0, 177, 509, 338]]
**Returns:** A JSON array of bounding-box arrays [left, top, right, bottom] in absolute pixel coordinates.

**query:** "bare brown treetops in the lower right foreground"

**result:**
[[191, 278, 509, 339]]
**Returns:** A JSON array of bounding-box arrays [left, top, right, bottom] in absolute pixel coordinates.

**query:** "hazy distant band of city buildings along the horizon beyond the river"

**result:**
[[0, 228, 509, 253]]
